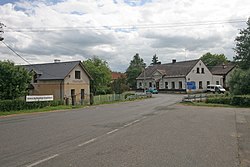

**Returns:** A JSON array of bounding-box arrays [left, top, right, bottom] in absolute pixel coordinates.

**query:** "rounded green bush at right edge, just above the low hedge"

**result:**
[[228, 69, 250, 95]]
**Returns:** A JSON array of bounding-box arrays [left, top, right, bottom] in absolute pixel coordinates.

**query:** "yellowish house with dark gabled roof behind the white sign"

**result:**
[[23, 61, 91, 104]]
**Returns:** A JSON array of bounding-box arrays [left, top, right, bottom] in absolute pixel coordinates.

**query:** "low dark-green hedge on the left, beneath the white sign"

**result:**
[[0, 100, 63, 112]]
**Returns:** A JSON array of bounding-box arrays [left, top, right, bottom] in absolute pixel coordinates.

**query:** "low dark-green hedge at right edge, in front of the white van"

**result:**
[[206, 95, 250, 107]]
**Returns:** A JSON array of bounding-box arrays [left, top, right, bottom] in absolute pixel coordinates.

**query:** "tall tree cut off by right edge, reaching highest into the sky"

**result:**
[[234, 17, 250, 69]]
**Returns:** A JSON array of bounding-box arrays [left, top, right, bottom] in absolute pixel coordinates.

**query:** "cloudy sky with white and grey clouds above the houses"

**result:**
[[0, 0, 250, 72]]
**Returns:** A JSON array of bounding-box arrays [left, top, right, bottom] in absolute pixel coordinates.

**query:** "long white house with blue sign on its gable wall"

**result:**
[[136, 59, 222, 92]]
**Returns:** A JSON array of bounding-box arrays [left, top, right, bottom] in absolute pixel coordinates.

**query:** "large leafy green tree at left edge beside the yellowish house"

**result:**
[[0, 61, 32, 100]]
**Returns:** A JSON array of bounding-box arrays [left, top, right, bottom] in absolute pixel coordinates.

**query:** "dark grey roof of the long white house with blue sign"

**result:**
[[137, 59, 199, 79]]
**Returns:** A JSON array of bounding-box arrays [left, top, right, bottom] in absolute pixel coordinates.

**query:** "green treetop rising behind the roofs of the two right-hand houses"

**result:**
[[200, 52, 228, 69]]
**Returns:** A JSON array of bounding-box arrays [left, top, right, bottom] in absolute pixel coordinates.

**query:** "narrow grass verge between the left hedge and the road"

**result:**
[[0, 105, 84, 116]]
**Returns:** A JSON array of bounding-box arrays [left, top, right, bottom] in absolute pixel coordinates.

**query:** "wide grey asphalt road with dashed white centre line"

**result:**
[[0, 95, 247, 167]]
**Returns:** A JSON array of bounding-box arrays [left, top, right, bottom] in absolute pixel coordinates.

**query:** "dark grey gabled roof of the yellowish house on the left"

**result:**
[[23, 61, 91, 80]]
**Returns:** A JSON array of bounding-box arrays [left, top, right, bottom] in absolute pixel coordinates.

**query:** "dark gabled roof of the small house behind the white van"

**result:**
[[210, 63, 235, 75]]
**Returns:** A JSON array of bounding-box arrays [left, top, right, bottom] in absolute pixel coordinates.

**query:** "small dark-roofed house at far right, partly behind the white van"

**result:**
[[210, 62, 236, 89]]
